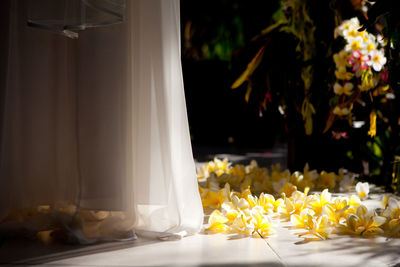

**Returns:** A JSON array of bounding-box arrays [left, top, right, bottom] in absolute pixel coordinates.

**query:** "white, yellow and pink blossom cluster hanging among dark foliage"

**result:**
[[332, 18, 389, 135]]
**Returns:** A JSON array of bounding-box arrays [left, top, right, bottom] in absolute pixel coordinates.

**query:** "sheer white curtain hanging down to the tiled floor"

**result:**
[[0, 0, 203, 243]]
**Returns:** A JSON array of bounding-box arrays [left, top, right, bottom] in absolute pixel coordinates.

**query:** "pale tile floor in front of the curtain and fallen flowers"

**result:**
[[0, 195, 400, 267]]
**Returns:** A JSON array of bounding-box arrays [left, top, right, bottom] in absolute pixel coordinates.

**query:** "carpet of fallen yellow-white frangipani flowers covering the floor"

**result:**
[[198, 159, 400, 240]]
